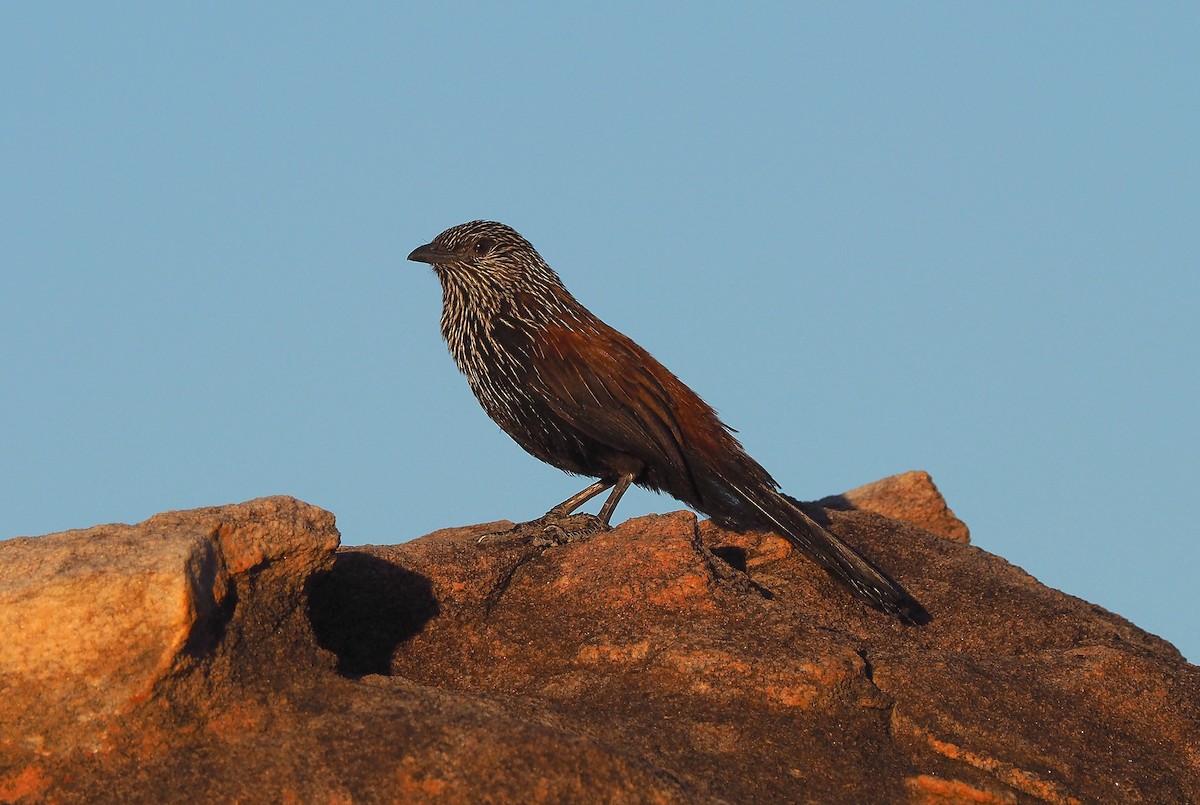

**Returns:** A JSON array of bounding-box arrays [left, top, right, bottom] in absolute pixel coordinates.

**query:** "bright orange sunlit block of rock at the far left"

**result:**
[[0, 498, 338, 752]]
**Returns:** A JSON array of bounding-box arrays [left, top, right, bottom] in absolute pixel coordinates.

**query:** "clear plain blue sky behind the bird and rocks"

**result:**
[[0, 2, 1200, 660]]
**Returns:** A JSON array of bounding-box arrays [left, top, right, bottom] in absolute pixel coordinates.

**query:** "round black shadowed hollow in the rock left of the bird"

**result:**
[[308, 549, 439, 678]]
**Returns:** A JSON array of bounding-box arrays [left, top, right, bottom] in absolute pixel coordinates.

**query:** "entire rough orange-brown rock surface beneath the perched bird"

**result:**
[[0, 474, 1200, 803]]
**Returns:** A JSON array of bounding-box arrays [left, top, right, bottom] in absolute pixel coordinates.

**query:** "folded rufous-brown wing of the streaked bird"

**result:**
[[530, 323, 691, 477]]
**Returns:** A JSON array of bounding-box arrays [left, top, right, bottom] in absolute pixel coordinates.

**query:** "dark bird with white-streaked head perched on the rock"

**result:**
[[408, 221, 930, 624]]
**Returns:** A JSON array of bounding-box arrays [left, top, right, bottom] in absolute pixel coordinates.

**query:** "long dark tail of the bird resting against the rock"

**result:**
[[710, 483, 931, 624]]
